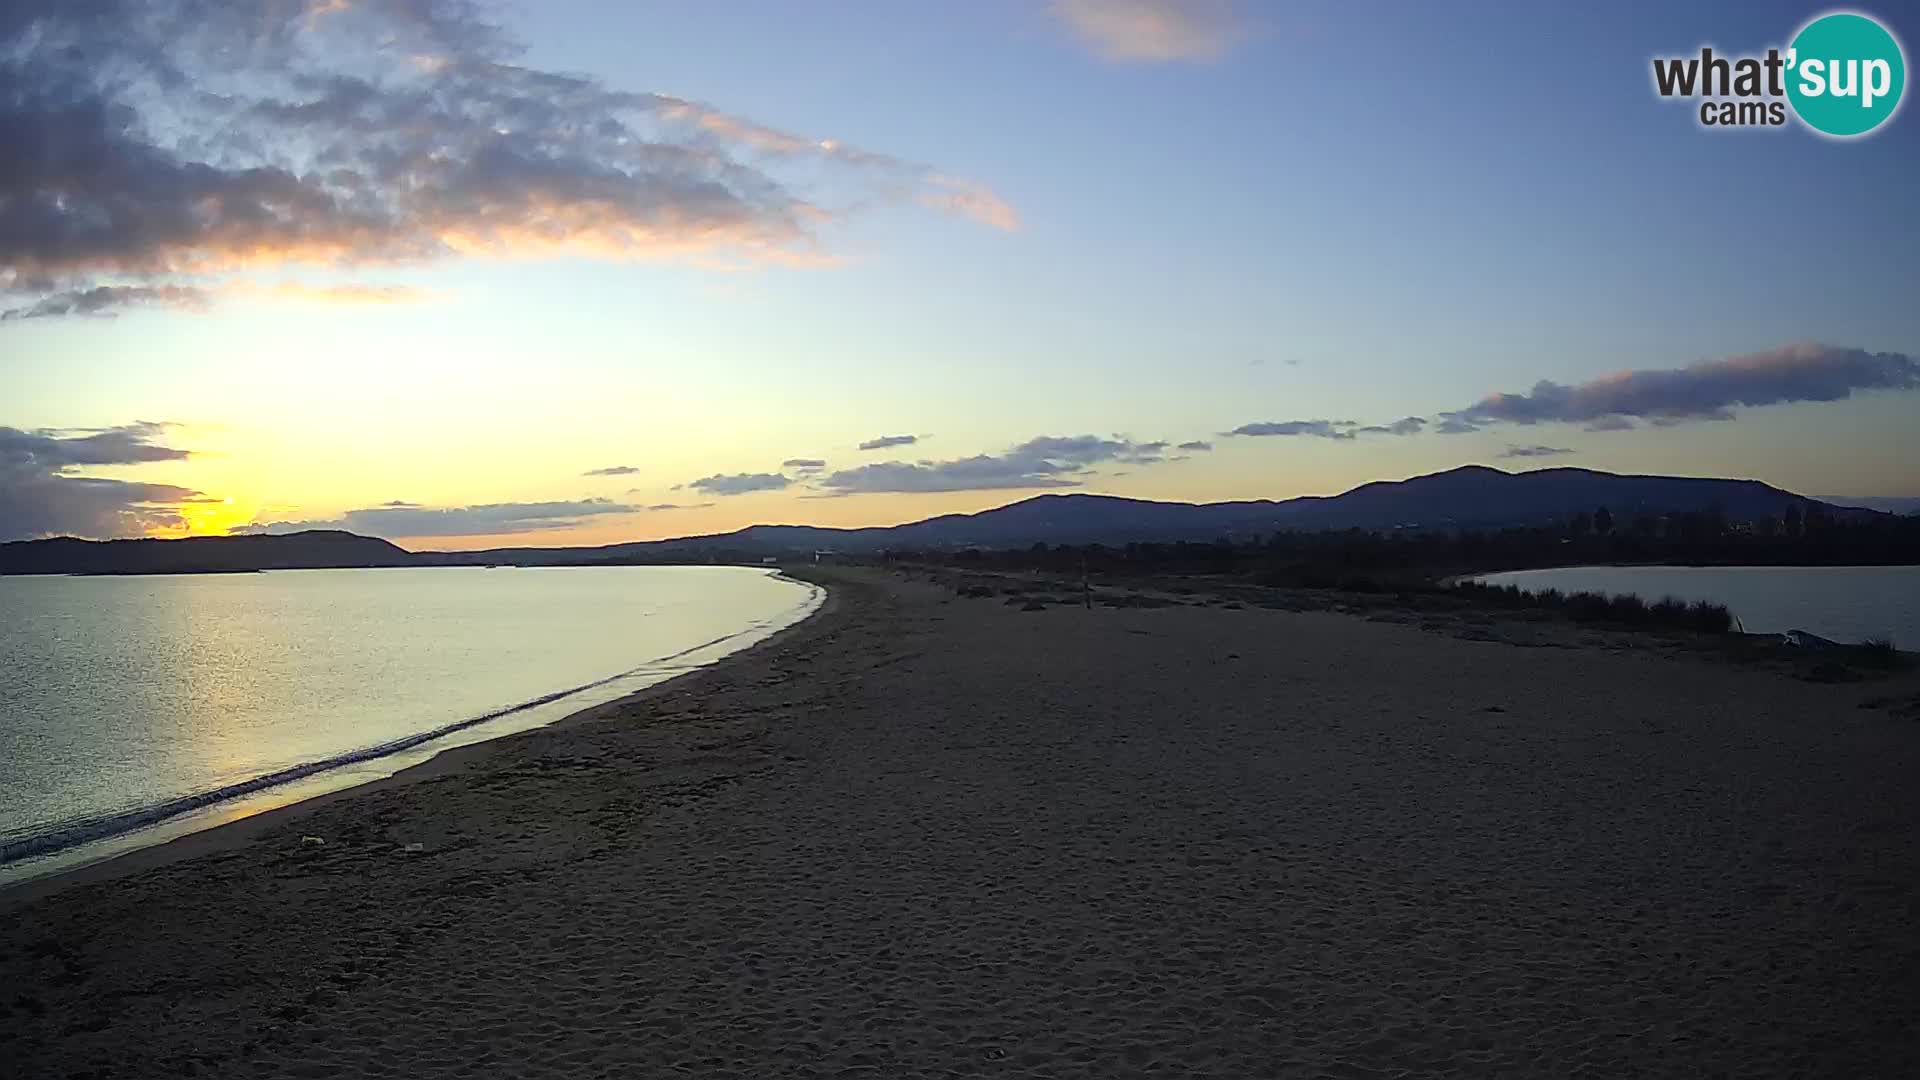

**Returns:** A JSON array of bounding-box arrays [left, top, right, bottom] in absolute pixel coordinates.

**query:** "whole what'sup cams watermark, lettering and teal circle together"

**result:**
[[1653, 12, 1907, 138]]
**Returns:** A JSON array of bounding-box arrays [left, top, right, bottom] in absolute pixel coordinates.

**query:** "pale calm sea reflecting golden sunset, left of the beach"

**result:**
[[0, 567, 822, 880]]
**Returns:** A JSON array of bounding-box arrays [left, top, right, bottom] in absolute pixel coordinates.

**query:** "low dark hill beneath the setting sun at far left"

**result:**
[[0, 530, 415, 575]]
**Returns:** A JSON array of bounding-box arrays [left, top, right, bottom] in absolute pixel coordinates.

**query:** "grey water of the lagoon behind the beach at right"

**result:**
[[1478, 567, 1920, 650]]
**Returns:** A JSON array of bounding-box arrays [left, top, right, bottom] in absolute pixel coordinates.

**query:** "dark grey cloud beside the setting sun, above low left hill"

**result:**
[[0, 423, 209, 540]]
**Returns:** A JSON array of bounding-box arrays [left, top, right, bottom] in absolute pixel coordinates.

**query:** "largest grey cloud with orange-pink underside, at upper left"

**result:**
[[0, 0, 1018, 317]]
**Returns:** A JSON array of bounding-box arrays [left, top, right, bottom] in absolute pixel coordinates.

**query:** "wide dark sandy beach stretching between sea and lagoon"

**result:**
[[0, 569, 1920, 1080]]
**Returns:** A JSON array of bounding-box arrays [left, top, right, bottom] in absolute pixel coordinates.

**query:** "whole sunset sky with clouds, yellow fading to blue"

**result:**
[[0, 0, 1920, 550]]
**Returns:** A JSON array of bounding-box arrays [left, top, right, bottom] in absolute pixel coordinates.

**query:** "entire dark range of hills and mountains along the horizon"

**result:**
[[0, 465, 1878, 575]]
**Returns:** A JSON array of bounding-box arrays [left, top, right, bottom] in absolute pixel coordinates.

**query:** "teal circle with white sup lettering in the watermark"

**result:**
[[1788, 12, 1907, 138]]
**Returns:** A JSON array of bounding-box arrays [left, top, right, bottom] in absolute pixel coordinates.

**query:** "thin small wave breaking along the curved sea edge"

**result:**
[[0, 578, 826, 865]]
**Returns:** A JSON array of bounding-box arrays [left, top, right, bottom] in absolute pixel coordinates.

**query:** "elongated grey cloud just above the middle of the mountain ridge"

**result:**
[[820, 434, 1167, 496]]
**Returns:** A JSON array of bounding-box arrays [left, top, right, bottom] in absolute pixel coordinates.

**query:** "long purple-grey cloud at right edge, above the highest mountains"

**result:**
[[1438, 342, 1920, 434]]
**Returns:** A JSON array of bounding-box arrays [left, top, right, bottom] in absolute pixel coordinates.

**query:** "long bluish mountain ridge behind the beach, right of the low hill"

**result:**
[[439, 465, 1872, 563]]
